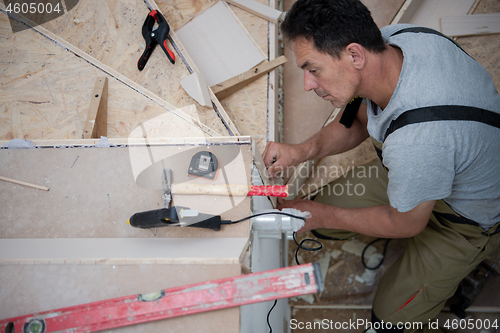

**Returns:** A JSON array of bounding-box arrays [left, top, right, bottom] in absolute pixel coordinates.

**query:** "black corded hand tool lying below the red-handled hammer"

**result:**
[[127, 207, 222, 231]]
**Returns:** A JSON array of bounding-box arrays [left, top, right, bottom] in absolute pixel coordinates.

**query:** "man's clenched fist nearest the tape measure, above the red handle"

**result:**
[[262, 141, 305, 179]]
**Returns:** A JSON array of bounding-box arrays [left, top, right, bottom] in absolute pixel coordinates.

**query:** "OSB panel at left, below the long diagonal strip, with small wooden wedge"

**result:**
[[0, 13, 225, 140]]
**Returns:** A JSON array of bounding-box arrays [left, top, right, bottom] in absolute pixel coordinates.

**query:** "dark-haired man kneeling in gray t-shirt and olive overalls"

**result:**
[[263, 0, 500, 332]]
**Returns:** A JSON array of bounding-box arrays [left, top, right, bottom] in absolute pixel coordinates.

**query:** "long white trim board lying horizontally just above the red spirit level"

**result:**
[[0, 237, 248, 266]]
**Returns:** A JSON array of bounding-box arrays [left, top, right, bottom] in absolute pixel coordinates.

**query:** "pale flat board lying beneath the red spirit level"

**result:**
[[0, 265, 242, 333]]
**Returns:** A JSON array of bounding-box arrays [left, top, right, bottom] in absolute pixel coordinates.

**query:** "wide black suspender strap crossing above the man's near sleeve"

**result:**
[[384, 105, 500, 141]]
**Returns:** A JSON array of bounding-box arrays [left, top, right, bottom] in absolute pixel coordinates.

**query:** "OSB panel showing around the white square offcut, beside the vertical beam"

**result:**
[[156, 0, 273, 152]]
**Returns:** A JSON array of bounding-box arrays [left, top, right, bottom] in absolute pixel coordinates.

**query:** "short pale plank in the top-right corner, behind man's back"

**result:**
[[441, 13, 500, 37]]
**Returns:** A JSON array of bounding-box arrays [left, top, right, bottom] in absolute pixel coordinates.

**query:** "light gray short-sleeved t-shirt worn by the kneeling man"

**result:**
[[368, 24, 500, 230]]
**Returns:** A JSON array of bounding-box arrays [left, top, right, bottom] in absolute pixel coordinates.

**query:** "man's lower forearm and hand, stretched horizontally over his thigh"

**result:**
[[278, 199, 435, 238]]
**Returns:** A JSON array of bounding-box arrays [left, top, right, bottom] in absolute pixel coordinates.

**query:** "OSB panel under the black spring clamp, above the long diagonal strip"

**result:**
[[34, 0, 228, 135]]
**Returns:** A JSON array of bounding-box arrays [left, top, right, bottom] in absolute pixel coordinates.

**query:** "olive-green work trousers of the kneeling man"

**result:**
[[314, 159, 500, 332]]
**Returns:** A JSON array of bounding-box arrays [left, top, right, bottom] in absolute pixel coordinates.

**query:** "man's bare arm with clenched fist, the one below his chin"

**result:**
[[262, 103, 368, 177]]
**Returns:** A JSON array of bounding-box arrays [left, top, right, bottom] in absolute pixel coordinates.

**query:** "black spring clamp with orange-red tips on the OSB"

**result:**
[[137, 10, 175, 71]]
